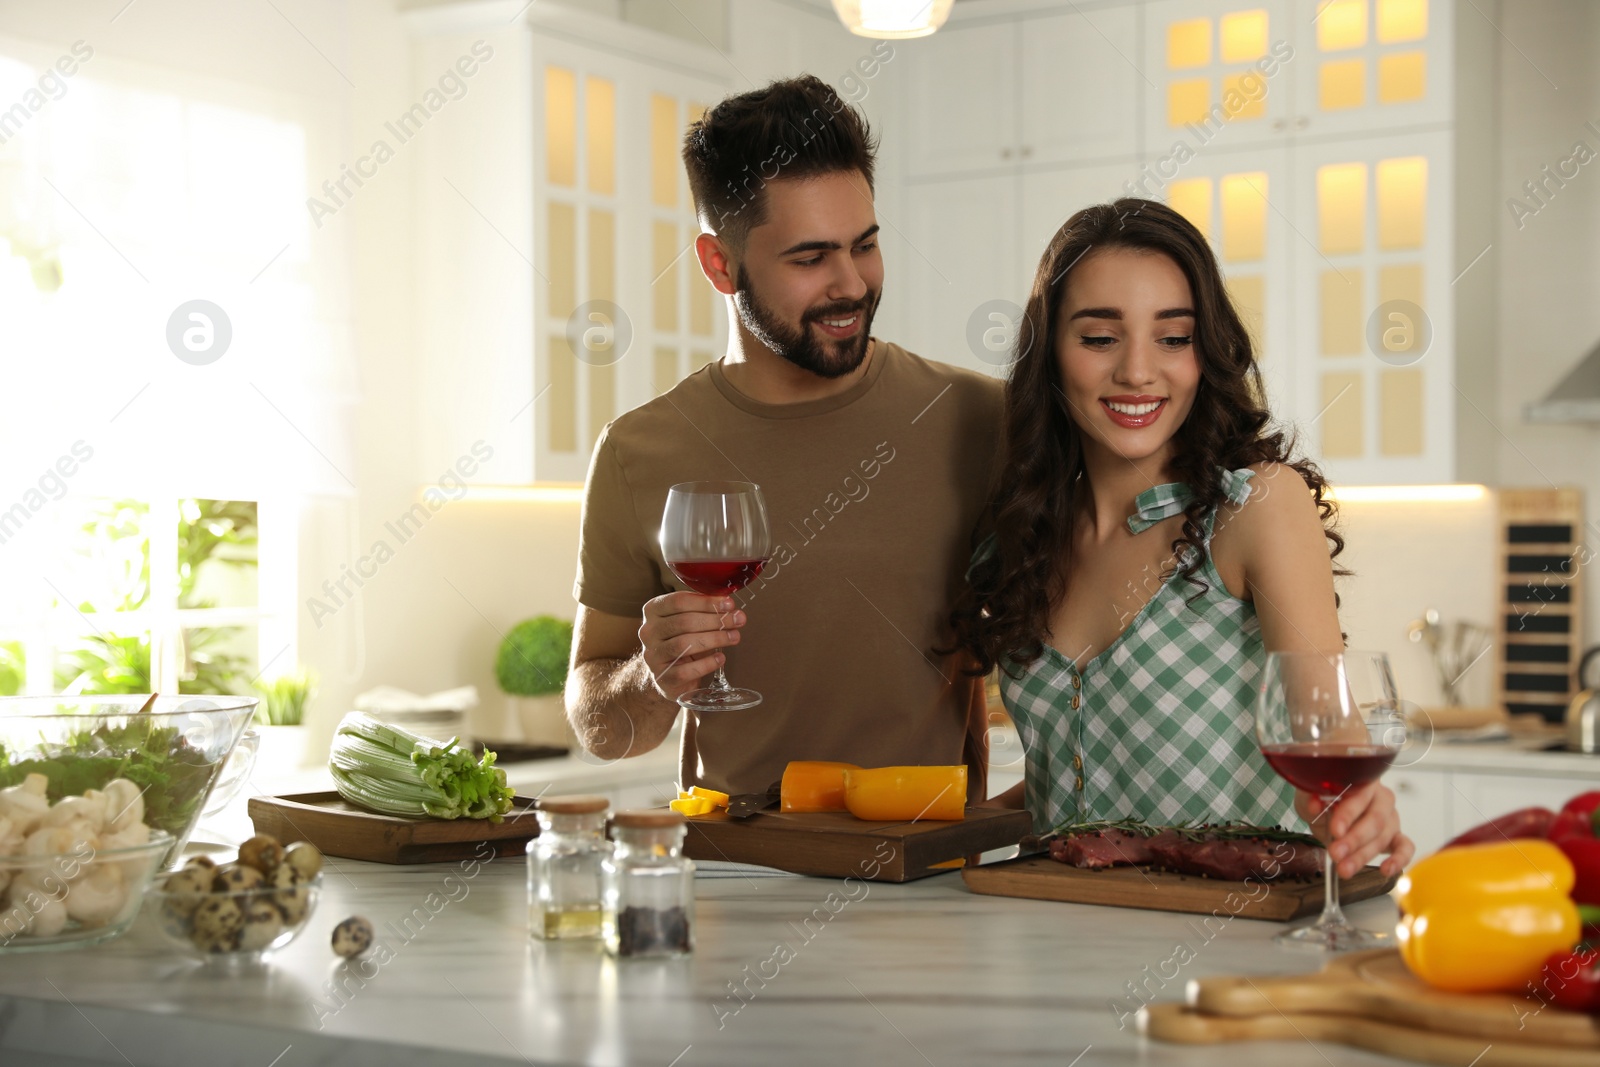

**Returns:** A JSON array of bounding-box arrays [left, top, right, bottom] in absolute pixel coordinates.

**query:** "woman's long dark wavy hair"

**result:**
[[950, 197, 1349, 673]]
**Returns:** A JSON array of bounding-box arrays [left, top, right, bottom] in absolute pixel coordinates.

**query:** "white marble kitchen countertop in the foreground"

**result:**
[[0, 831, 1427, 1067]]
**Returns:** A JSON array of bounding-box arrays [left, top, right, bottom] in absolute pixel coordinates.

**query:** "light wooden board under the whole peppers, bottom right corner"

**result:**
[[1139, 949, 1600, 1067]]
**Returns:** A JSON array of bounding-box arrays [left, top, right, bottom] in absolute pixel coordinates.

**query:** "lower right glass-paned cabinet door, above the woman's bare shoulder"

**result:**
[[1288, 131, 1456, 485]]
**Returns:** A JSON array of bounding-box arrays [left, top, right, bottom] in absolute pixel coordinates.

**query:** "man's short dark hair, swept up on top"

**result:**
[[683, 74, 878, 250]]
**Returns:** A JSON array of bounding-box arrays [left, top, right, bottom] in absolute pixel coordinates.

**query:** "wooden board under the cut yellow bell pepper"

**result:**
[[683, 808, 1032, 881]]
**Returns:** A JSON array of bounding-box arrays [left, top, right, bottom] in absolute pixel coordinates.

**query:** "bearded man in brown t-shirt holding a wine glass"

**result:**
[[566, 75, 1002, 800]]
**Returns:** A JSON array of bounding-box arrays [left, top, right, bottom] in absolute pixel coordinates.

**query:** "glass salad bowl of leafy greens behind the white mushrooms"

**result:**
[[0, 696, 259, 867]]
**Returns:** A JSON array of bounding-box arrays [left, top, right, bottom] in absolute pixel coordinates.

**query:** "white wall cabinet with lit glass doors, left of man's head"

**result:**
[[408, 5, 730, 483]]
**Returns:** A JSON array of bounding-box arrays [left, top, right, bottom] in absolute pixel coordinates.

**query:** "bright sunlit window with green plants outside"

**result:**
[[0, 38, 348, 693]]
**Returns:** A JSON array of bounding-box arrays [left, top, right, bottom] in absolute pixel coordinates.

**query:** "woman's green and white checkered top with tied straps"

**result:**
[[979, 470, 1304, 832]]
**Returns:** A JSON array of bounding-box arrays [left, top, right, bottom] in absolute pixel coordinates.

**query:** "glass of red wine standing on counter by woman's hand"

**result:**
[[1256, 653, 1406, 952]]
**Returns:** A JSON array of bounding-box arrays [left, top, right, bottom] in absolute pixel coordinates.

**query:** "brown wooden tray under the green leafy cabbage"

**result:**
[[250, 790, 539, 864]]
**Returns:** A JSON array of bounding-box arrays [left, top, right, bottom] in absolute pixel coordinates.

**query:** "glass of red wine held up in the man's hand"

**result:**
[[661, 482, 773, 712]]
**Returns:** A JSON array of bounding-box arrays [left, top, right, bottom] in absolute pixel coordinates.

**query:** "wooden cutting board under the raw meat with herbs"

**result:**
[[962, 856, 1400, 921]]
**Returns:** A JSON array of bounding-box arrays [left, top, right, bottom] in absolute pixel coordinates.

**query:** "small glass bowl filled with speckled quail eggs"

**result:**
[[146, 833, 322, 966]]
